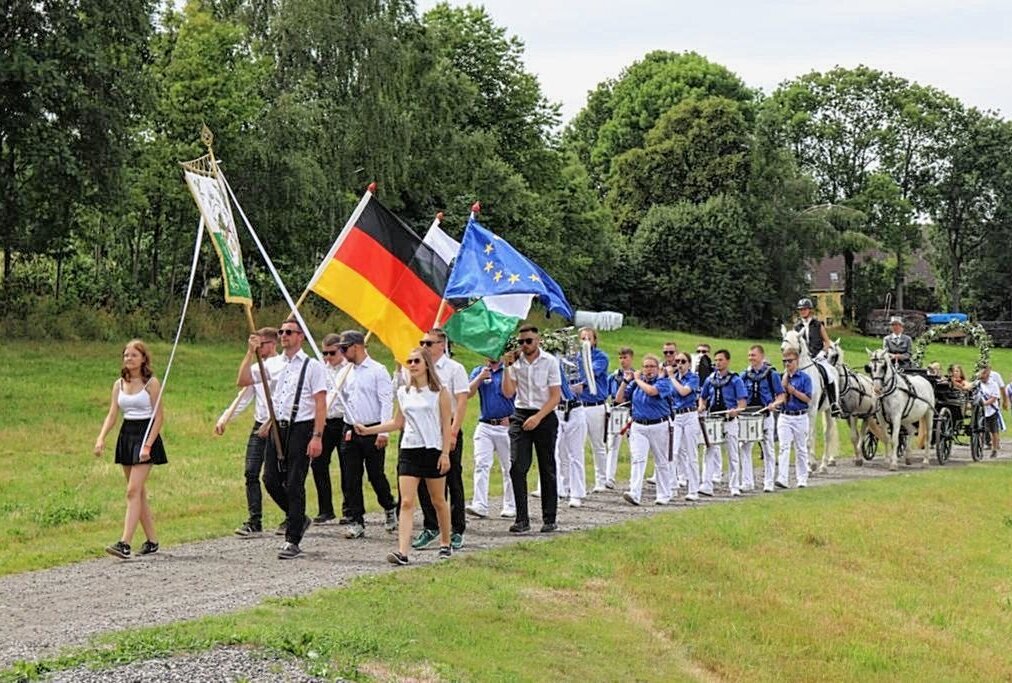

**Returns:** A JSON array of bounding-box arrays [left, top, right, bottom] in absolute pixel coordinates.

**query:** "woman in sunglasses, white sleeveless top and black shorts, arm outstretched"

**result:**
[[355, 347, 453, 565]]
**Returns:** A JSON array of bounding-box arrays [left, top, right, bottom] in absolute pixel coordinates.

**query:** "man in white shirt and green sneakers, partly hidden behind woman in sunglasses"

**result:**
[[411, 327, 470, 550]]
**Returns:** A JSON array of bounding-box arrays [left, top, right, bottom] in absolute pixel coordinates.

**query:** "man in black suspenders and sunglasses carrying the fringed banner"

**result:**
[[238, 318, 327, 560]]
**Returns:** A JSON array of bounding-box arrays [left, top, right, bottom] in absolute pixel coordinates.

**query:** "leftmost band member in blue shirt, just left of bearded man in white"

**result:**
[[465, 358, 516, 517]]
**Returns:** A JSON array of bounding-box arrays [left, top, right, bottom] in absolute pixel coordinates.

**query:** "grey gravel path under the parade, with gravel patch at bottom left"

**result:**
[[0, 448, 995, 681]]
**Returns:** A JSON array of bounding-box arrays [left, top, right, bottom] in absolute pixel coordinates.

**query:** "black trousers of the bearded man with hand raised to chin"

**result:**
[[509, 410, 559, 524]]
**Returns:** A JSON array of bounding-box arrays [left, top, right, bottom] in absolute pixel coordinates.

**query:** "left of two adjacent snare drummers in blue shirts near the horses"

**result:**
[[698, 349, 748, 497]]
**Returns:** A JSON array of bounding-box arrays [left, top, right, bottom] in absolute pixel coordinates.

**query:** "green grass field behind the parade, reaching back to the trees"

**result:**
[[0, 328, 1012, 576]]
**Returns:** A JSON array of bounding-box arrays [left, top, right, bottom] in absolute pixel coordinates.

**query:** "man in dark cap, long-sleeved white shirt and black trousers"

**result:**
[[340, 330, 397, 538]]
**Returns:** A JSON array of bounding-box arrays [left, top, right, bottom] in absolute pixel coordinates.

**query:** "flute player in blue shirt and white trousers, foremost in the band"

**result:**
[[618, 353, 674, 505]]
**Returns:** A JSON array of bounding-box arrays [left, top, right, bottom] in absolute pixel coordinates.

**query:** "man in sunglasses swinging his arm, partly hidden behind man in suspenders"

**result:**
[[215, 327, 283, 538]]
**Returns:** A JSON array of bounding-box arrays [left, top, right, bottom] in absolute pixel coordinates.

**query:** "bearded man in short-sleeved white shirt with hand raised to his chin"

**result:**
[[503, 325, 563, 533]]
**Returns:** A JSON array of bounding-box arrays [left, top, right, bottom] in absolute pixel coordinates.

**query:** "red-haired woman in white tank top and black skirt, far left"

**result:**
[[95, 339, 168, 560]]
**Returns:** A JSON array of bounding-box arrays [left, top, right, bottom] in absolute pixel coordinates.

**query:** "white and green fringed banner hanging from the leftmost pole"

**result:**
[[183, 162, 253, 306]]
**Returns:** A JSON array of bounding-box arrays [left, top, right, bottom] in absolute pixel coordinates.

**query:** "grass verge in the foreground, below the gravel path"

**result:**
[[5, 464, 1012, 681]]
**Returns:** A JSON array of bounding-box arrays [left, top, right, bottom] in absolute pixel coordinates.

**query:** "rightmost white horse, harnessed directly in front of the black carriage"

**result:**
[[865, 349, 935, 469]]
